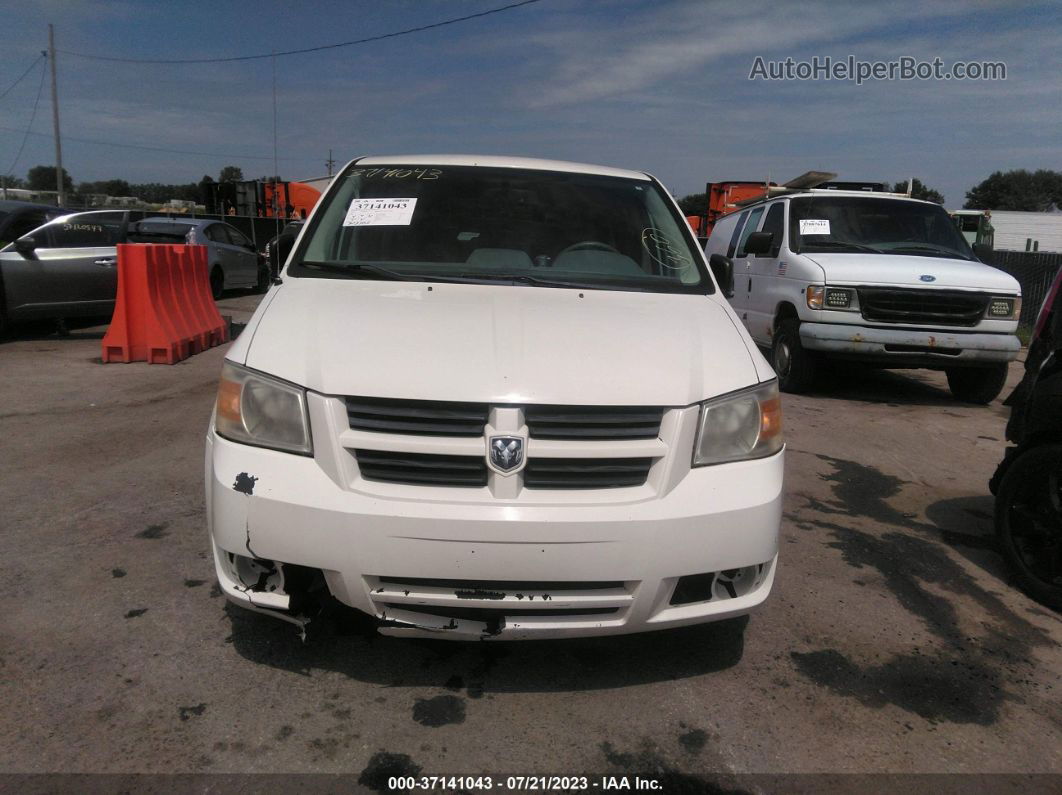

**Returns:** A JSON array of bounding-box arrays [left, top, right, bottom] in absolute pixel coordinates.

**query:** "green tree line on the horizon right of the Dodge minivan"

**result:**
[[679, 169, 1062, 215]]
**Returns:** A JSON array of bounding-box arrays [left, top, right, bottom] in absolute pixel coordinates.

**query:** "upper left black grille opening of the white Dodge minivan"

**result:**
[[346, 397, 489, 436]]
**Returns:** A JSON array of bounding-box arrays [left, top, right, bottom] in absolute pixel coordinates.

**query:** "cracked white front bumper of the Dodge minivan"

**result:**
[[206, 429, 784, 640]]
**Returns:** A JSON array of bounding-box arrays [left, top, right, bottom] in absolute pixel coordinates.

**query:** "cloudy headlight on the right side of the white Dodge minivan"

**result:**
[[693, 381, 782, 467]]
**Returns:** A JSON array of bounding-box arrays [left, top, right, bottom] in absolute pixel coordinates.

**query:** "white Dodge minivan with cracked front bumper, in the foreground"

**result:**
[[206, 156, 783, 639]]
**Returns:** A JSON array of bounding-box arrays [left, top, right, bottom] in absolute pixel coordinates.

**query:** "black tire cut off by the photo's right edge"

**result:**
[[995, 444, 1062, 610]]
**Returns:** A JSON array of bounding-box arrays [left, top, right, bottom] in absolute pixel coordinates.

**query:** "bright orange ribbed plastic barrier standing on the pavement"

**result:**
[[103, 243, 228, 364]]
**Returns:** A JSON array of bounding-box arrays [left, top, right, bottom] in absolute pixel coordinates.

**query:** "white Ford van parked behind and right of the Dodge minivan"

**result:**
[[705, 189, 1022, 403]]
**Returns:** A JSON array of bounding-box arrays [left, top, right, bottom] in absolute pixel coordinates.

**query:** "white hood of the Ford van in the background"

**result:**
[[804, 252, 1021, 293]]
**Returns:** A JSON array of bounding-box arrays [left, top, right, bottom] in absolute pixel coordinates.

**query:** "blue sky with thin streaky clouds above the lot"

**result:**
[[0, 0, 1062, 207]]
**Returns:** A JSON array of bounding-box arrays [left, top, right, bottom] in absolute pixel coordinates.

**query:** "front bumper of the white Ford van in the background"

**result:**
[[800, 323, 1022, 367]]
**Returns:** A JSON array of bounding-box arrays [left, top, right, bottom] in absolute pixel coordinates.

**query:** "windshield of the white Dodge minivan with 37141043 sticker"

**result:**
[[288, 163, 713, 293]]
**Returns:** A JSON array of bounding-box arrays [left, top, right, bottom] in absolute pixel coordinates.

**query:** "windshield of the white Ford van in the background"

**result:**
[[789, 195, 974, 260]]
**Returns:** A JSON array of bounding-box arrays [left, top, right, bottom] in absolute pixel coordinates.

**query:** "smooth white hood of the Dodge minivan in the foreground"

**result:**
[[240, 277, 759, 405]]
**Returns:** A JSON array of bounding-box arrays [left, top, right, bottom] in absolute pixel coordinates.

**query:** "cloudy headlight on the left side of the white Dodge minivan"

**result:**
[[215, 362, 313, 454]]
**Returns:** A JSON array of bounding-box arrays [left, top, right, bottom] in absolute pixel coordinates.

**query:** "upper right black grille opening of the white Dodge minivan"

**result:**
[[524, 405, 664, 440]]
